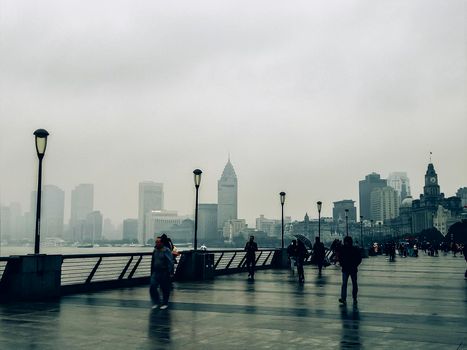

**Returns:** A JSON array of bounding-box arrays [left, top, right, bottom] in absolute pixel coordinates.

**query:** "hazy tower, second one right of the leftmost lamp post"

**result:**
[[70, 184, 94, 241]]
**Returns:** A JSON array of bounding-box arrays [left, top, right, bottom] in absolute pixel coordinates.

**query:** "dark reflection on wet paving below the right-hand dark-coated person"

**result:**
[[340, 305, 362, 349]]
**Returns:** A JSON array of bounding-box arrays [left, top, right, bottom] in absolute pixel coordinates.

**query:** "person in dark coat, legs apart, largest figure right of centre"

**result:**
[[339, 236, 362, 305]]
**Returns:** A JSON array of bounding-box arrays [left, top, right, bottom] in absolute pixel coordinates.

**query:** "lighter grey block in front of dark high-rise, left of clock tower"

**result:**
[[370, 186, 399, 222]]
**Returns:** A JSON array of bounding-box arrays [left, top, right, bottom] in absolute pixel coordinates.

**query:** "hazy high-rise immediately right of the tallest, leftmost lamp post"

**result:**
[[41, 185, 65, 237]]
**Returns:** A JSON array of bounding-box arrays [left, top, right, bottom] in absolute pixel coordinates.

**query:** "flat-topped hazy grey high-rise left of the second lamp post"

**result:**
[[138, 181, 164, 244]]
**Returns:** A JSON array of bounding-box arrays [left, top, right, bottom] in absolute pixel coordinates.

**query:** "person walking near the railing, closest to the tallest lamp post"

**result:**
[[149, 237, 174, 310]]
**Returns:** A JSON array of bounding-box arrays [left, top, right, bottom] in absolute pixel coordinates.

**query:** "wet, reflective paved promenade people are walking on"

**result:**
[[0, 253, 467, 350]]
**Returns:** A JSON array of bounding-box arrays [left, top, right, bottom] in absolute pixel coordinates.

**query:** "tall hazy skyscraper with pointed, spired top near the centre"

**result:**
[[217, 158, 238, 230]]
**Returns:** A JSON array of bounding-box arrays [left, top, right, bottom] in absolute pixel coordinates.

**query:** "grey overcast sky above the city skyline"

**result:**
[[0, 0, 467, 223]]
